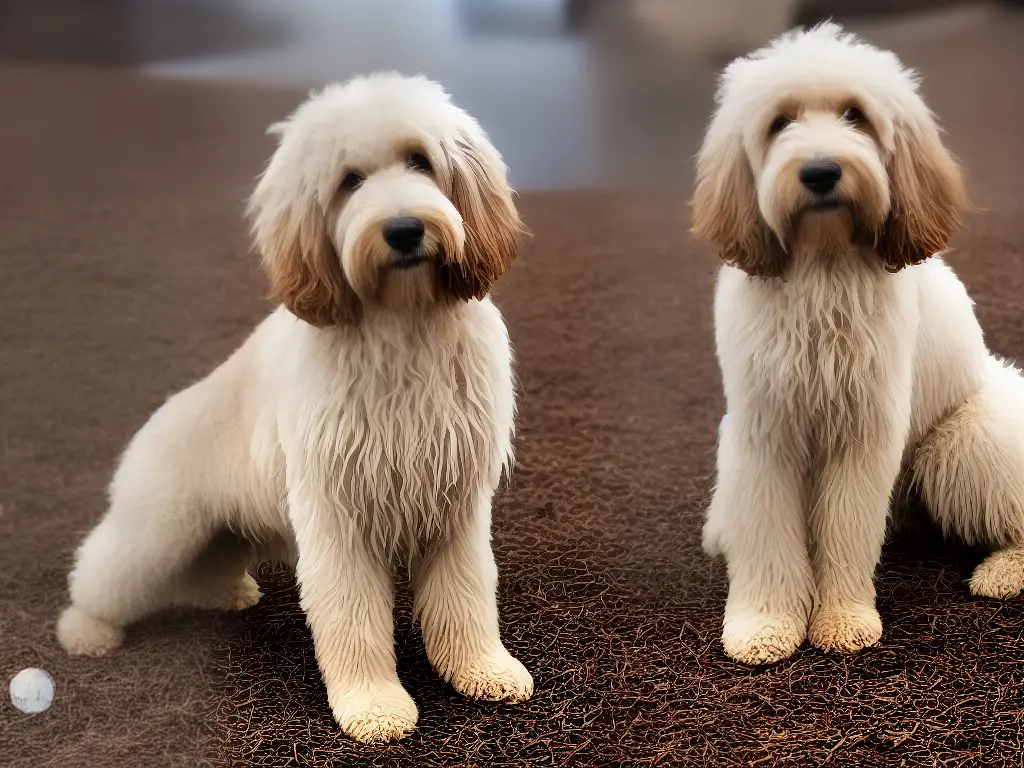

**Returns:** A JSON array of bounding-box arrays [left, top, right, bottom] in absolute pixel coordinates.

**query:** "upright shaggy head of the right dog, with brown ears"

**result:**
[[693, 24, 967, 276]]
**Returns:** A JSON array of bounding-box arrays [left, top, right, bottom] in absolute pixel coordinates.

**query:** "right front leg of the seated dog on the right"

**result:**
[[808, 409, 909, 653]]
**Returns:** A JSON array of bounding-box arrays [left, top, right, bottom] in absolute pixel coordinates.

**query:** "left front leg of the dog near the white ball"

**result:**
[[289, 483, 418, 742]]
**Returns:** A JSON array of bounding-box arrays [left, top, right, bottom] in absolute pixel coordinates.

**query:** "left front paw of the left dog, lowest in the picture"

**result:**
[[328, 682, 419, 743]]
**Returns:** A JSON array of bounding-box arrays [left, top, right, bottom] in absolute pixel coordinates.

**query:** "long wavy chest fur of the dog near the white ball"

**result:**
[[288, 309, 512, 552]]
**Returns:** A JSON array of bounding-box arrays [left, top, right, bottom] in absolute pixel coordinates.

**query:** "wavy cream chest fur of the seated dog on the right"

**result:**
[[729, 254, 912, 449]]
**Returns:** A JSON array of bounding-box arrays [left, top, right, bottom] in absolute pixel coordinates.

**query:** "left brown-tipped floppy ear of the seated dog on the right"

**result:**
[[690, 123, 786, 278]]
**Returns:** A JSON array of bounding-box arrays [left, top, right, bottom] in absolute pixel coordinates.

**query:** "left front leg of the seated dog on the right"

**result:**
[[705, 417, 814, 665]]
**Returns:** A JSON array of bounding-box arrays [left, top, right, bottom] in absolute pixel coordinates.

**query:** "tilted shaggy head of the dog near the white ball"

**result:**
[[250, 73, 523, 327]]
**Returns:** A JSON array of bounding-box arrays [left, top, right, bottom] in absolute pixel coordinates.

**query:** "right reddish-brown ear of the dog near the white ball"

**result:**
[[437, 133, 525, 301]]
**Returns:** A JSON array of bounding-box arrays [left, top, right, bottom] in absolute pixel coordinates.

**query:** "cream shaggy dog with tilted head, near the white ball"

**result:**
[[58, 74, 534, 741]]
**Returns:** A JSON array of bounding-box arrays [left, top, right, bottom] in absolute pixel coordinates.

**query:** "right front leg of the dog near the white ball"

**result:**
[[415, 493, 534, 701]]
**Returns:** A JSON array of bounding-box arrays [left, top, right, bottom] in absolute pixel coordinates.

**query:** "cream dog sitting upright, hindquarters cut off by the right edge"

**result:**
[[693, 24, 1024, 665]]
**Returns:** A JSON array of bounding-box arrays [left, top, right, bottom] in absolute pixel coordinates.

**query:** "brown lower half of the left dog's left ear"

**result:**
[[256, 212, 360, 328]]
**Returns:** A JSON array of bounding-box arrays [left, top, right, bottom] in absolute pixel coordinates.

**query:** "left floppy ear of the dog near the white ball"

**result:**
[[249, 126, 361, 328]]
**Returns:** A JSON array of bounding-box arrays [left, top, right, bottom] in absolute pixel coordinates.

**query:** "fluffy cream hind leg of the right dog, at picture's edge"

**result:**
[[913, 357, 1024, 598]]
